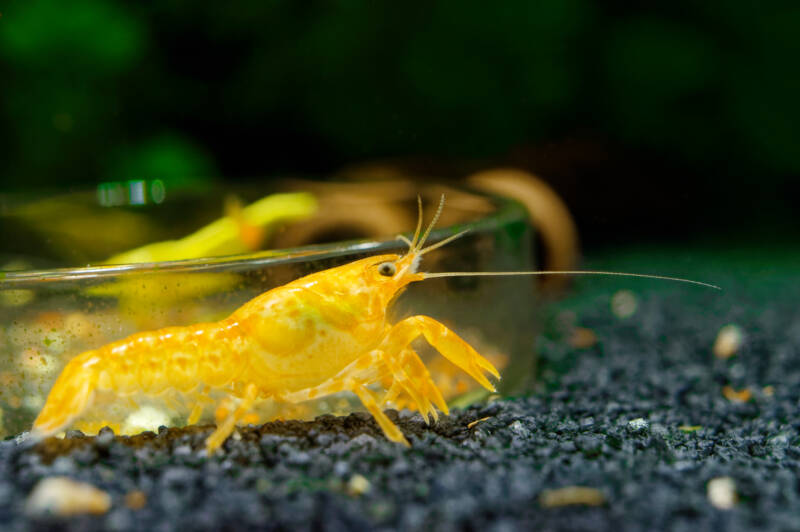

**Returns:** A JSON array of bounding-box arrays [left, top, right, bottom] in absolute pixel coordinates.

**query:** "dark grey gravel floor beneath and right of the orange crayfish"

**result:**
[[0, 243, 800, 531]]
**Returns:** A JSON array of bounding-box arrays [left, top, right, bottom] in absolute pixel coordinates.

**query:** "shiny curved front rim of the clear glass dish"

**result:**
[[0, 190, 527, 289]]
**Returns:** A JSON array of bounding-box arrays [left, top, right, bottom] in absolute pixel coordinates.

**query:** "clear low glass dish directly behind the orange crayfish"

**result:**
[[0, 181, 537, 437]]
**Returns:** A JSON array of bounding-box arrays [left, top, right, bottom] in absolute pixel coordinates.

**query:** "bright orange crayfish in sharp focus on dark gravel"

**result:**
[[32, 197, 720, 453]]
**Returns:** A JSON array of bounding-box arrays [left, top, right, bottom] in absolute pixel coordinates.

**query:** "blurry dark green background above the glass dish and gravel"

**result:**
[[0, 0, 800, 245]]
